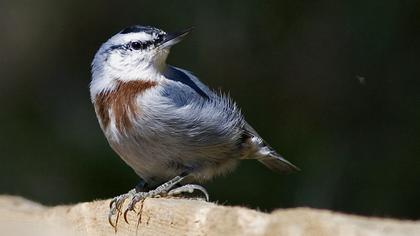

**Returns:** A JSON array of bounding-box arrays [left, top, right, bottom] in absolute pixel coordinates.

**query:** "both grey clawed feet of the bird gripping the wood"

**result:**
[[108, 176, 209, 230]]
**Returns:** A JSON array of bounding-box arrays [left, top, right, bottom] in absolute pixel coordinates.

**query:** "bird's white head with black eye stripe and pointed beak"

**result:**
[[91, 25, 192, 95]]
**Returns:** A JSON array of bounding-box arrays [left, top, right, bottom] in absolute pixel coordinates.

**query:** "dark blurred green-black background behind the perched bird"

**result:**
[[0, 0, 420, 219]]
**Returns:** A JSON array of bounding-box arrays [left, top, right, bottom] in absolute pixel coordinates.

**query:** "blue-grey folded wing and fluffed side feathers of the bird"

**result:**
[[150, 66, 243, 149]]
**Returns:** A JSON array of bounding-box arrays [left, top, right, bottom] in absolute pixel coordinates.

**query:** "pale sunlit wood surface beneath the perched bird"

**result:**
[[0, 196, 420, 236]]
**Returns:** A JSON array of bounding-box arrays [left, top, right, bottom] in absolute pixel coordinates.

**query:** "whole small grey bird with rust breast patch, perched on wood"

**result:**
[[90, 25, 299, 226]]
